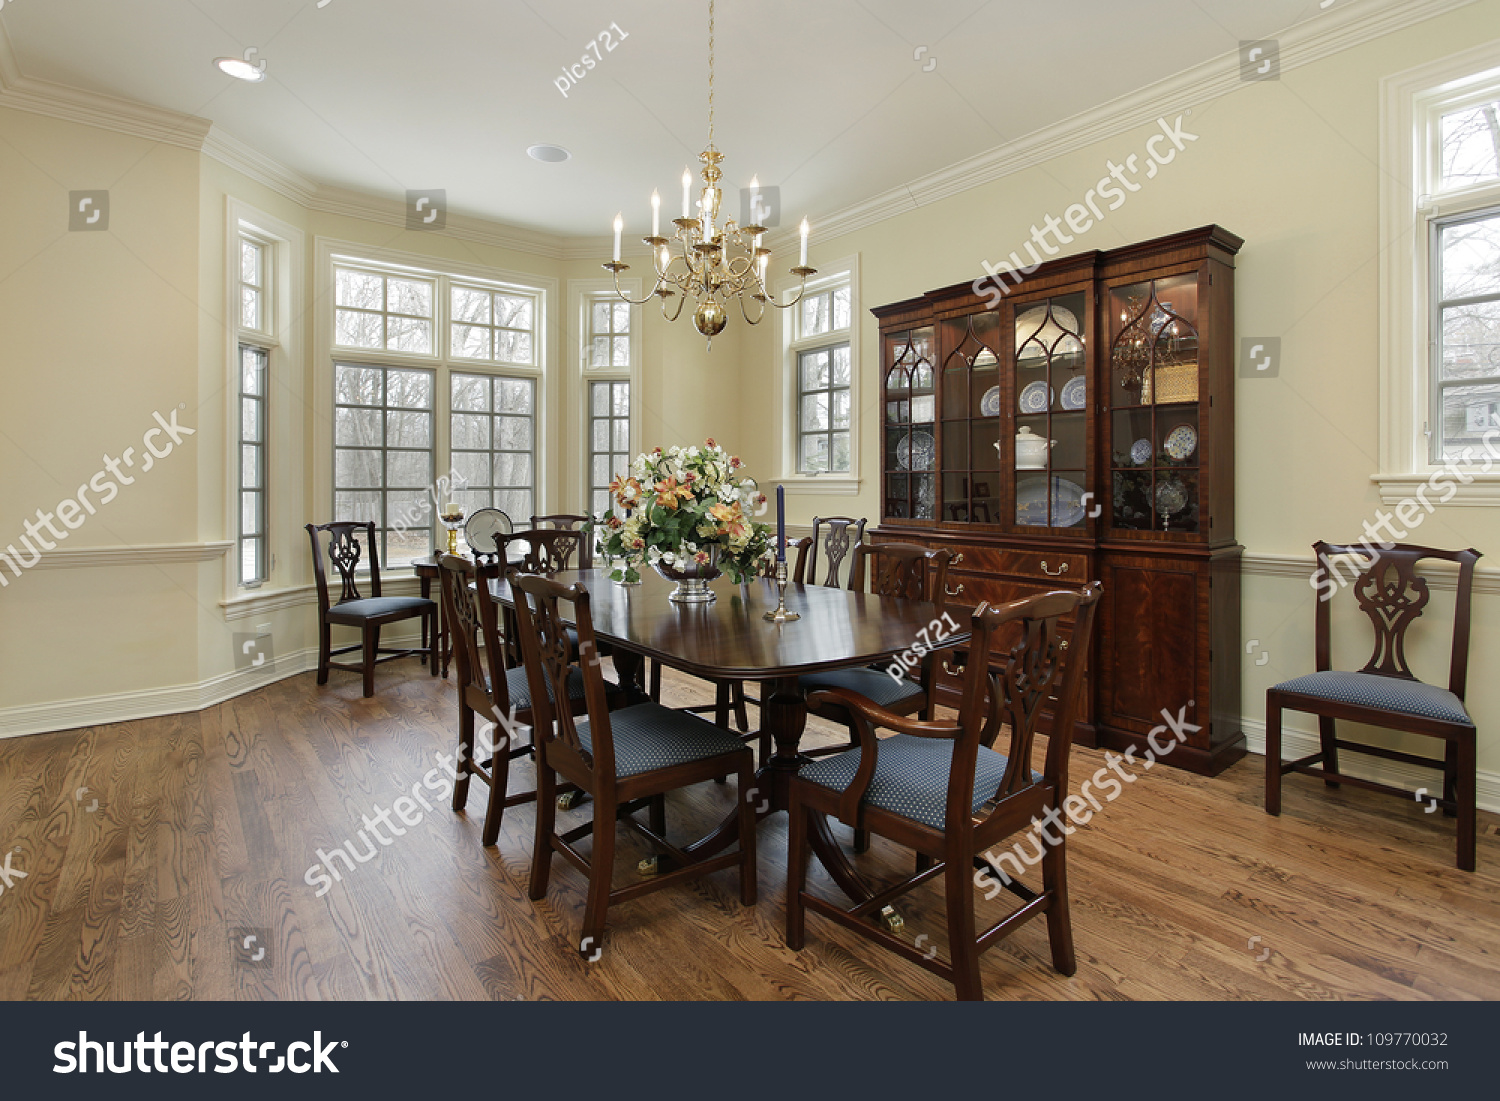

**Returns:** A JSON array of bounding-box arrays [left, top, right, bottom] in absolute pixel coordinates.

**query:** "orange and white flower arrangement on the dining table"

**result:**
[[590, 438, 776, 585]]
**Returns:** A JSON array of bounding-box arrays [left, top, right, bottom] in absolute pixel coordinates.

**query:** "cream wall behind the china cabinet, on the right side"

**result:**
[[741, 5, 1500, 806]]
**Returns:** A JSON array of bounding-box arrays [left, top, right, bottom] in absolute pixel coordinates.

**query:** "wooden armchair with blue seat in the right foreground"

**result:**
[[786, 582, 1103, 1001]]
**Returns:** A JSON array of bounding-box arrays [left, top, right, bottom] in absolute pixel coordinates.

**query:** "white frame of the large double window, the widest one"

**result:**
[[314, 237, 558, 555]]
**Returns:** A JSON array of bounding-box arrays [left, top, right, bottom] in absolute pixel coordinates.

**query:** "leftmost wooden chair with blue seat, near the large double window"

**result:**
[[306, 521, 440, 699]]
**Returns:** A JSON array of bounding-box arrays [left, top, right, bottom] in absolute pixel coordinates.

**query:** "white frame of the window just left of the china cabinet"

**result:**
[[774, 254, 864, 497]]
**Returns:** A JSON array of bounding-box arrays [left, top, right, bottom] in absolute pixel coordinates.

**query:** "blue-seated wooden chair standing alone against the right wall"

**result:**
[[1266, 542, 1482, 872]]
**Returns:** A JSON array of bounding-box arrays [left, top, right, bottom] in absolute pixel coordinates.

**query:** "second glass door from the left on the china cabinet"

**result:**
[[939, 311, 1001, 524]]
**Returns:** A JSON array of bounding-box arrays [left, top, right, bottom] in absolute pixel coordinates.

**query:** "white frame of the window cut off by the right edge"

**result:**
[[1371, 39, 1500, 506]]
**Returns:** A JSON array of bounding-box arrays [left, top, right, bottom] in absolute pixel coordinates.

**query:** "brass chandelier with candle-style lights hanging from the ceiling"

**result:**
[[605, 0, 818, 350]]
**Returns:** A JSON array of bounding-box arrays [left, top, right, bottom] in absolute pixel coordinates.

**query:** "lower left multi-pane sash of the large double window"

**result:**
[[333, 363, 434, 566]]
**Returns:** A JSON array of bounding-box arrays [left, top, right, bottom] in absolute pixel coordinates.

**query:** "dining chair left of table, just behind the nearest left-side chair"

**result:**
[[438, 555, 584, 848]]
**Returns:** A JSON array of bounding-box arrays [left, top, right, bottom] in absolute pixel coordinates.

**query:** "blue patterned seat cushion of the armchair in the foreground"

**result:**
[[801, 738, 1041, 830]]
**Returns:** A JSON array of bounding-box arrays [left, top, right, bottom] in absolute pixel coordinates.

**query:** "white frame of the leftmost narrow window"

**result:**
[[221, 197, 306, 612]]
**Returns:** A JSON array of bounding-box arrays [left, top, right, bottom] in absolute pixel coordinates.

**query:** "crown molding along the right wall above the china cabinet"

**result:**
[[771, 0, 1478, 249]]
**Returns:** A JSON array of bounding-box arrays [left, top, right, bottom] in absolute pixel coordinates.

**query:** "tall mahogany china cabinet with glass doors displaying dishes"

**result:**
[[870, 227, 1245, 774]]
